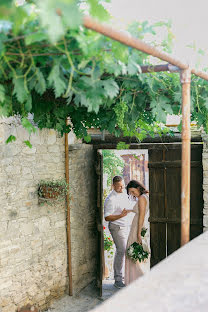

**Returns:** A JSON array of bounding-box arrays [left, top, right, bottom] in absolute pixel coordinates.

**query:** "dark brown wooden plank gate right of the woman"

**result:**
[[149, 144, 203, 267]]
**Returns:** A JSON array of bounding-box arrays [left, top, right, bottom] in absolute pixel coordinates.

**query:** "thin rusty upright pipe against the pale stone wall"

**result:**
[[65, 119, 73, 296]]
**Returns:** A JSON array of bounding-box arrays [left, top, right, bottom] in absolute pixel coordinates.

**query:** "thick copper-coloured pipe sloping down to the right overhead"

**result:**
[[83, 16, 208, 80]]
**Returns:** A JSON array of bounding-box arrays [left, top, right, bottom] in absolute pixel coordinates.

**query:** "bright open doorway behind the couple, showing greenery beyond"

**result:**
[[102, 149, 150, 298]]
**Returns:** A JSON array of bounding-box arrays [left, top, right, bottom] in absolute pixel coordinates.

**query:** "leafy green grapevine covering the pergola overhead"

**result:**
[[0, 0, 208, 146]]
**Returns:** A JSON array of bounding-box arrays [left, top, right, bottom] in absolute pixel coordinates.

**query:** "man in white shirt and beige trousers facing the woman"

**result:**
[[104, 176, 130, 288]]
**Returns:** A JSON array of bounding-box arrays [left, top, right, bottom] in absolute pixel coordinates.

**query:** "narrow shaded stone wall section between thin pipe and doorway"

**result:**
[[69, 144, 98, 293]]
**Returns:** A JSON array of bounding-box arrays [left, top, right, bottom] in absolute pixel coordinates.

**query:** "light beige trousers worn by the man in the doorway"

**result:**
[[109, 222, 128, 282]]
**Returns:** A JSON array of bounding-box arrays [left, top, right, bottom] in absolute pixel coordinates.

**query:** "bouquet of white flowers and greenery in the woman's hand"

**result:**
[[127, 229, 150, 263]]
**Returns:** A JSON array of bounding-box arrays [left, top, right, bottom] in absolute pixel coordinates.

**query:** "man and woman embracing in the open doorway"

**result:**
[[104, 176, 149, 288]]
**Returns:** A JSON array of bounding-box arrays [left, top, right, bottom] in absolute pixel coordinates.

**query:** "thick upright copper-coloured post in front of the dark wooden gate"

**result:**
[[180, 69, 191, 246]]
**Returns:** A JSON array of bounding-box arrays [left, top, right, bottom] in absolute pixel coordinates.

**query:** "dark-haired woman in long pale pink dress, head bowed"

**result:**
[[125, 180, 150, 286]]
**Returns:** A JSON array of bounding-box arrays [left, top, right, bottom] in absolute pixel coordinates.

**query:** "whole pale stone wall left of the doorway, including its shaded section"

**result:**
[[0, 118, 97, 312]]
